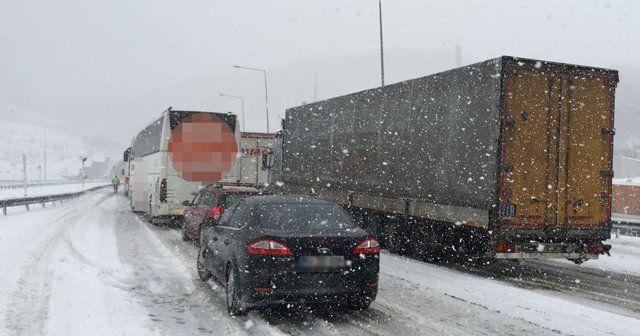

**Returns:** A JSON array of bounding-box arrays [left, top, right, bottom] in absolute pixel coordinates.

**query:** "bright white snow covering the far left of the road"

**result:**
[[0, 192, 155, 336]]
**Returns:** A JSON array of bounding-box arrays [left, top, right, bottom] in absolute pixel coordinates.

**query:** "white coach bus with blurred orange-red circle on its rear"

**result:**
[[124, 108, 240, 223]]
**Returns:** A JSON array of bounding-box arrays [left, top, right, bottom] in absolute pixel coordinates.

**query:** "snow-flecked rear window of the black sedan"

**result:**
[[256, 204, 356, 231]]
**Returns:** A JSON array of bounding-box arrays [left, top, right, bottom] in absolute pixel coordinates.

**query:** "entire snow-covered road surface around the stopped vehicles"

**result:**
[[0, 189, 640, 336]]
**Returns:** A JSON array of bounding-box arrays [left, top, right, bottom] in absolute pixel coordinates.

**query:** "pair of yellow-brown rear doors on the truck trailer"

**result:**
[[500, 66, 615, 229]]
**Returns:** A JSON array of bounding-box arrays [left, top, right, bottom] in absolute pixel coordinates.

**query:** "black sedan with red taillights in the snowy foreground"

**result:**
[[197, 196, 380, 315]]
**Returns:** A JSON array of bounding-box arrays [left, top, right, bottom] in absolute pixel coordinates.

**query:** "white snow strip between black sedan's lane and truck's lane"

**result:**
[[380, 253, 640, 336]]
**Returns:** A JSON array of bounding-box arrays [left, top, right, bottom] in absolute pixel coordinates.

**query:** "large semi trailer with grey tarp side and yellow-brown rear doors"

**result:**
[[265, 56, 618, 263]]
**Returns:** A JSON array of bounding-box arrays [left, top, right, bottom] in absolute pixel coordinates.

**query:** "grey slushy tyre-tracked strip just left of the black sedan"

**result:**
[[110, 198, 278, 336]]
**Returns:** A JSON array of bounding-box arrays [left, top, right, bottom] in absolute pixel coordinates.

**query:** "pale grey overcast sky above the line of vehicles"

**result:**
[[0, 0, 640, 152]]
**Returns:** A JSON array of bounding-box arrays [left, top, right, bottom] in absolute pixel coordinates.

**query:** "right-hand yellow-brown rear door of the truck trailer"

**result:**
[[557, 76, 614, 227]]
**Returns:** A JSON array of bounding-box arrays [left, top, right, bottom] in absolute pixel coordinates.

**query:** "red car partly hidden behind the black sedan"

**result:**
[[182, 184, 262, 242]]
